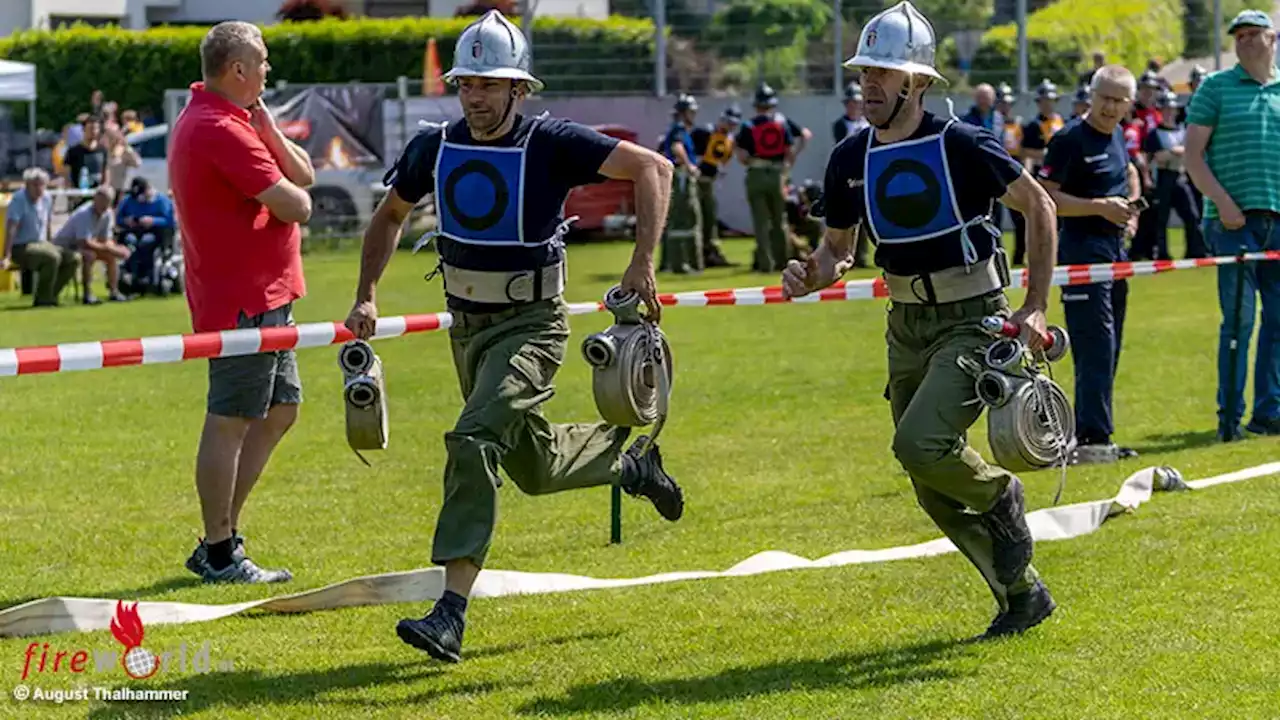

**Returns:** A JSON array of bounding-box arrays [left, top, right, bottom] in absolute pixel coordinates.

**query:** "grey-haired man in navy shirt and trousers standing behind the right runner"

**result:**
[[1039, 65, 1142, 462]]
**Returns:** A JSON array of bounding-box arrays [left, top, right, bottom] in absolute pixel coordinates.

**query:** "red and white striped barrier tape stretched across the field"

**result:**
[[0, 250, 1280, 377]]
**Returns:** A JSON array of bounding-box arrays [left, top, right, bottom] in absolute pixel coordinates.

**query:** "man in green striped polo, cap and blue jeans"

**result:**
[[1183, 10, 1280, 442]]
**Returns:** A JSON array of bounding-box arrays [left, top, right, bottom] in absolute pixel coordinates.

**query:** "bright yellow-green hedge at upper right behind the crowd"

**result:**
[[969, 0, 1183, 88]]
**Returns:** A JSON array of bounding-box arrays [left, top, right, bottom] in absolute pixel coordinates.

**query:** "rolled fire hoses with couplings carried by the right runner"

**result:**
[[960, 318, 1075, 505]]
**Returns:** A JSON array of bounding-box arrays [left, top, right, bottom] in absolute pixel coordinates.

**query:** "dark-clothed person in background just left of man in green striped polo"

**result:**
[[1134, 91, 1207, 260]]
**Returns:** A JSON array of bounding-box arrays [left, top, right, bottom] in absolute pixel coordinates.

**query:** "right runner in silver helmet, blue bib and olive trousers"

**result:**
[[782, 1, 1056, 638]]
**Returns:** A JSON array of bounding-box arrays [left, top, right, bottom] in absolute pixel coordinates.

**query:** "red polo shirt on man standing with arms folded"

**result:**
[[169, 82, 306, 332]]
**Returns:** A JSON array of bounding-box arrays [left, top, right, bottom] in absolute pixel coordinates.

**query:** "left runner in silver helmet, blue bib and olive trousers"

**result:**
[[346, 10, 684, 662]]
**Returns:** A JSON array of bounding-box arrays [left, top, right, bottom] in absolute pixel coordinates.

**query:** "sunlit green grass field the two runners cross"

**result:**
[[0, 233, 1280, 719]]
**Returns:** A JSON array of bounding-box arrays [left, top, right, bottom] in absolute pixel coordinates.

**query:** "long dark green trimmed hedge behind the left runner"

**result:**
[[0, 17, 654, 128]]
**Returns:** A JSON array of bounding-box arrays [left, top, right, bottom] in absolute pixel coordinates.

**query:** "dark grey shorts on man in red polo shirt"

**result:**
[[209, 304, 302, 419]]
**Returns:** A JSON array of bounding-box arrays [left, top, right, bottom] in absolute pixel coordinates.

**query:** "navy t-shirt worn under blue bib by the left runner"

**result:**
[[384, 115, 620, 313]]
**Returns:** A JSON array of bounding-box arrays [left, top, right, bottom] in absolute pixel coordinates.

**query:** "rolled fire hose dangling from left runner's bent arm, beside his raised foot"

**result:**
[[582, 286, 675, 451]]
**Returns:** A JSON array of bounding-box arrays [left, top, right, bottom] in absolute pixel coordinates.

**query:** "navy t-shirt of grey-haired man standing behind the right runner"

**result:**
[[1037, 114, 1129, 243]]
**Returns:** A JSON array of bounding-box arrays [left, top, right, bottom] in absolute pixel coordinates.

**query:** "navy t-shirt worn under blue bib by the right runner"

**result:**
[[823, 111, 1023, 275]]
